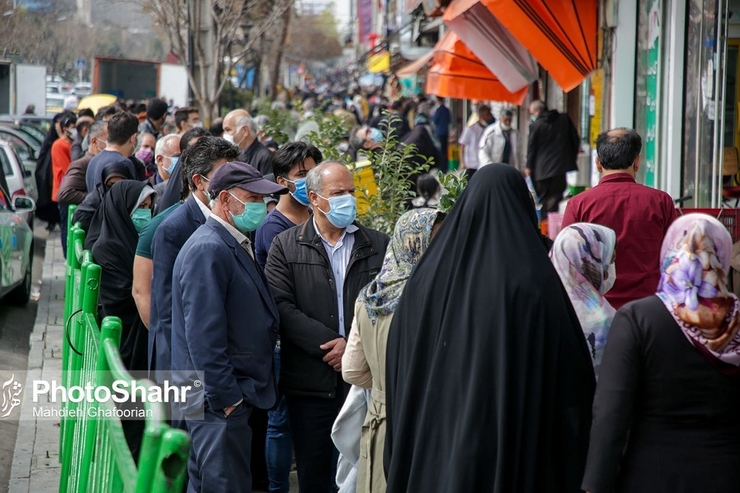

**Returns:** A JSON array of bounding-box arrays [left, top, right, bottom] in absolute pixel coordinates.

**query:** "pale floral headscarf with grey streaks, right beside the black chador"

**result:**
[[550, 223, 617, 370]]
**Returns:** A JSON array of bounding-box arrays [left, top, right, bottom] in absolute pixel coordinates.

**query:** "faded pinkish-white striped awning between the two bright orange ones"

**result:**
[[443, 0, 539, 92]]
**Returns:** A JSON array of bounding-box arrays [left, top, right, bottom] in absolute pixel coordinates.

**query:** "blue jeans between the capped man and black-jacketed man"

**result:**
[[265, 346, 293, 493]]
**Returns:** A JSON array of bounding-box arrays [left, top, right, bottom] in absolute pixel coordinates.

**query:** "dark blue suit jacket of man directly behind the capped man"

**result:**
[[148, 195, 206, 376]]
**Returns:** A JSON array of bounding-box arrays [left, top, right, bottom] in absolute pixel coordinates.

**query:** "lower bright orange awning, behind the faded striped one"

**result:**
[[426, 31, 528, 105]]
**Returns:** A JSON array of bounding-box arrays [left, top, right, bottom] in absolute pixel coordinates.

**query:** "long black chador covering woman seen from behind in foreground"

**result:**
[[385, 164, 595, 493]]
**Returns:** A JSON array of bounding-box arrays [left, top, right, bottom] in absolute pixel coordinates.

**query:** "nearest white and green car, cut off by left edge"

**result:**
[[0, 186, 36, 306]]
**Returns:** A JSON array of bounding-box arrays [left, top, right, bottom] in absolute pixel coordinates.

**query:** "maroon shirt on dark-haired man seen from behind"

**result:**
[[562, 173, 677, 308]]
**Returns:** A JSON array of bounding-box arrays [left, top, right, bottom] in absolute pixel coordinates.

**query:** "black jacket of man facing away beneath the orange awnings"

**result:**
[[527, 110, 581, 181]]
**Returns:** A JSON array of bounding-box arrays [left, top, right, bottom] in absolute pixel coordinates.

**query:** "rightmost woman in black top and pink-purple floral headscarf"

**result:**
[[581, 214, 740, 493]]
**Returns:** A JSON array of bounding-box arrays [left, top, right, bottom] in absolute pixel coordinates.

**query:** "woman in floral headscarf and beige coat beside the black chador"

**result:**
[[342, 209, 442, 493]]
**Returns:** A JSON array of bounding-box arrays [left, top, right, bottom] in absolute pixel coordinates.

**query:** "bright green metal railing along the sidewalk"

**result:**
[[59, 207, 190, 493]]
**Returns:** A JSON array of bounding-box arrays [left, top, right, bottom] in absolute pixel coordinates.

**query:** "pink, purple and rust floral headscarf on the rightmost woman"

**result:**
[[657, 214, 740, 367]]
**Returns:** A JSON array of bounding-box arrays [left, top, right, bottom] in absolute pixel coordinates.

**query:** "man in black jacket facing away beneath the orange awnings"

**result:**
[[524, 101, 581, 213]]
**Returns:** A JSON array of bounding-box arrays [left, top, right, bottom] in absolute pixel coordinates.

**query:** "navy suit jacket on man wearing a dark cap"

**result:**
[[171, 217, 279, 413]]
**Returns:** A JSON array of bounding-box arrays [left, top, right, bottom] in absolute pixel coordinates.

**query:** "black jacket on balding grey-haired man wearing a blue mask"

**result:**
[[265, 219, 388, 398]]
